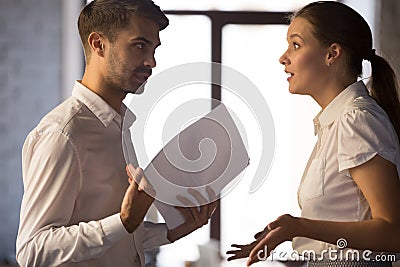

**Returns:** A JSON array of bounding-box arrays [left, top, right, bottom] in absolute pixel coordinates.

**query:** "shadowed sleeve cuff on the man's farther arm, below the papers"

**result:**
[[143, 221, 171, 250]]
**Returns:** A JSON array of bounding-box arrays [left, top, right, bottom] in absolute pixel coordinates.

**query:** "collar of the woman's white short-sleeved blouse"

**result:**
[[314, 81, 369, 135]]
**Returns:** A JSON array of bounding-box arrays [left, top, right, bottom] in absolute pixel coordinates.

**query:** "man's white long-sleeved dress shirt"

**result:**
[[17, 82, 169, 267]]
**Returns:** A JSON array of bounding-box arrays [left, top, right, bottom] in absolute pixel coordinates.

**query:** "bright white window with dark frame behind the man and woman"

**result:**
[[81, 0, 377, 267]]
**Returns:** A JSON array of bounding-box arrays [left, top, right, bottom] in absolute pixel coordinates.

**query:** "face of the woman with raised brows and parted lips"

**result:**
[[279, 18, 329, 98]]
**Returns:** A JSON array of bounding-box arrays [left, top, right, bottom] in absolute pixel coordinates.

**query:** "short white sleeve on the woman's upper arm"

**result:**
[[338, 109, 397, 176]]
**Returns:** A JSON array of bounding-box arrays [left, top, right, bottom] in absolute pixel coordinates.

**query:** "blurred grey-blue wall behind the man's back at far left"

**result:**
[[0, 0, 61, 262]]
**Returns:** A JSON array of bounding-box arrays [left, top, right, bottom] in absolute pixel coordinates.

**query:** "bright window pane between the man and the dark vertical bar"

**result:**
[[132, 15, 211, 267]]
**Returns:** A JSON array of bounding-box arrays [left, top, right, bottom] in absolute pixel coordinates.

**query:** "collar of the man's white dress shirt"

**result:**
[[72, 81, 121, 127]]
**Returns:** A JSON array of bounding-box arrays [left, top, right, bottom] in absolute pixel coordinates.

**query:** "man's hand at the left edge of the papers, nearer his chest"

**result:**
[[120, 165, 154, 233]]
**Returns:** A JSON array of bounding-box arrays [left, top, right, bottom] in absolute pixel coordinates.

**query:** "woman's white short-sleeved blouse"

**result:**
[[293, 81, 400, 255]]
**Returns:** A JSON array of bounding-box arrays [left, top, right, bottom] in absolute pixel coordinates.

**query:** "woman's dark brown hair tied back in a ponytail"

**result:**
[[292, 1, 400, 142]]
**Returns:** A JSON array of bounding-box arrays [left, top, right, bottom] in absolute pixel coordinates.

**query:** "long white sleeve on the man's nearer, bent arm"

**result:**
[[17, 131, 128, 266]]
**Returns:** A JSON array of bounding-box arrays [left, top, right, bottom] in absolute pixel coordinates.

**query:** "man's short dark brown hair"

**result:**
[[78, 0, 169, 59]]
